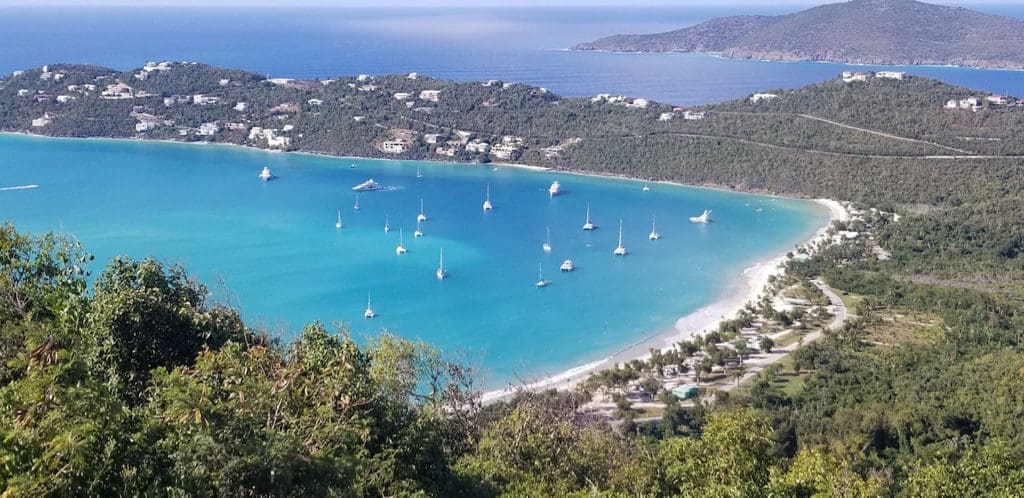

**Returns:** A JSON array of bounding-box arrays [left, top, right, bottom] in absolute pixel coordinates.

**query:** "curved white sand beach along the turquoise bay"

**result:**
[[481, 199, 849, 404]]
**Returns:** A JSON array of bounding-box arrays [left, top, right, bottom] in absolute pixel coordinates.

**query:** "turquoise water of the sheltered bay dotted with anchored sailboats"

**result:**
[[0, 135, 827, 387]]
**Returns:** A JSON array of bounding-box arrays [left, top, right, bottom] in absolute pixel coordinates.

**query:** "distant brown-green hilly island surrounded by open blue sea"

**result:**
[[572, 0, 1024, 70]]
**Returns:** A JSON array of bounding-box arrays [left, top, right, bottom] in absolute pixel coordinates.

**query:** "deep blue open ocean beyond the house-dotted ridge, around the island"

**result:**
[[0, 4, 1024, 105]]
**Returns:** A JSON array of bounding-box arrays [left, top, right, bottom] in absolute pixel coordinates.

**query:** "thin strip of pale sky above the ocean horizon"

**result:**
[[0, 0, 1011, 8]]
